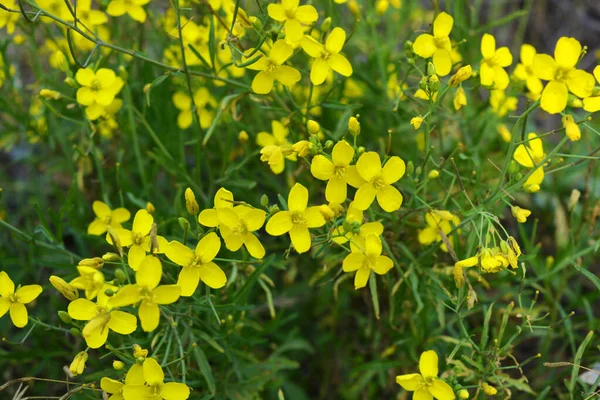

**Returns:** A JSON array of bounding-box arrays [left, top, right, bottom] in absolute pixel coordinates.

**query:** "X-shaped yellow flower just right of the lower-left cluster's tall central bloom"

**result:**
[[166, 232, 227, 297]]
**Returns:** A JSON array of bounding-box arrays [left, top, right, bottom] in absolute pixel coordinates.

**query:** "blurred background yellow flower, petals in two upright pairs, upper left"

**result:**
[[173, 87, 217, 129]]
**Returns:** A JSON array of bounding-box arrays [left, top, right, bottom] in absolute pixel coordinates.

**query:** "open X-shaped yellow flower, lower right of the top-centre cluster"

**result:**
[[300, 28, 352, 85]]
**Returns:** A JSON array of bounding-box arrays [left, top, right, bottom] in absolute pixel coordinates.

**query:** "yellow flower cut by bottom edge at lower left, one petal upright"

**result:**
[[123, 358, 190, 400]]
